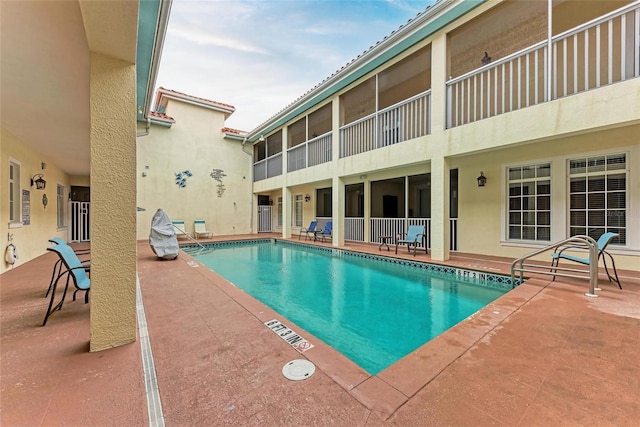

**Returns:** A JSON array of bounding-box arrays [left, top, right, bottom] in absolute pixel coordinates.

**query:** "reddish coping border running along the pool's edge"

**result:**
[[181, 238, 549, 420]]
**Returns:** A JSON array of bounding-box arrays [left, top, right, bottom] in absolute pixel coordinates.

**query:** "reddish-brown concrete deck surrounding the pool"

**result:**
[[0, 234, 640, 426]]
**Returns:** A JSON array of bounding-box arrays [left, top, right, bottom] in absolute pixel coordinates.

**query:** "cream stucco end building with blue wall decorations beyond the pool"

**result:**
[[137, 87, 252, 240]]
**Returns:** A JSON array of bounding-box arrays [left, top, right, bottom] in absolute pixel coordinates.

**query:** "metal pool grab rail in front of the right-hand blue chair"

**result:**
[[511, 235, 598, 297]]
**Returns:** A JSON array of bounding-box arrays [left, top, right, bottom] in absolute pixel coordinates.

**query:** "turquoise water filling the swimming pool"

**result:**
[[188, 241, 506, 375]]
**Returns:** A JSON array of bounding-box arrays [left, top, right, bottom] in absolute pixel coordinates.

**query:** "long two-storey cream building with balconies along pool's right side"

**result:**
[[242, 1, 640, 270]]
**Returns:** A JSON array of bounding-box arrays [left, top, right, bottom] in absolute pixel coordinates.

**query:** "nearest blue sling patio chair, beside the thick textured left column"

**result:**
[[42, 244, 91, 326]]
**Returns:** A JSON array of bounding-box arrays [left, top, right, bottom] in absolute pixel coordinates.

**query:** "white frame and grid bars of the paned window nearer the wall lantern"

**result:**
[[504, 161, 553, 244]]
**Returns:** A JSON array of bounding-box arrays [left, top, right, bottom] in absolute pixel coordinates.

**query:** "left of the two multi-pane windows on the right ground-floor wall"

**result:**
[[508, 163, 551, 242]]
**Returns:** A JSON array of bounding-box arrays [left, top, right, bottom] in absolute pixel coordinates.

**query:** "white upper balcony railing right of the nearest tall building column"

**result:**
[[446, 2, 640, 128]]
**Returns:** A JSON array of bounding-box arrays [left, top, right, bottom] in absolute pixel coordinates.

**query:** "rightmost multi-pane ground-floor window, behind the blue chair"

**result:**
[[569, 154, 627, 245]]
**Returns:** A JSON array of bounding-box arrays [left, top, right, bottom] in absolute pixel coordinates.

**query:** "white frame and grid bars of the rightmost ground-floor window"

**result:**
[[566, 151, 631, 247]]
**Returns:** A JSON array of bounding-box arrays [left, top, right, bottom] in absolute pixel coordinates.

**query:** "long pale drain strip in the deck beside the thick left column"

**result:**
[[136, 275, 164, 427]]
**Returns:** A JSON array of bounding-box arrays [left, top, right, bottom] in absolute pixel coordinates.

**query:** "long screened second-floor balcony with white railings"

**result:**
[[254, 1, 640, 181]]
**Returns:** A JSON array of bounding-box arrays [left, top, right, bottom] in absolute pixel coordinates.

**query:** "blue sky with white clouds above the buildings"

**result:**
[[156, 0, 433, 131]]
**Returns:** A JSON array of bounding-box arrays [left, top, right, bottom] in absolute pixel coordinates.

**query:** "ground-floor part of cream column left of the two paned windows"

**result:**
[[431, 157, 450, 261]]
